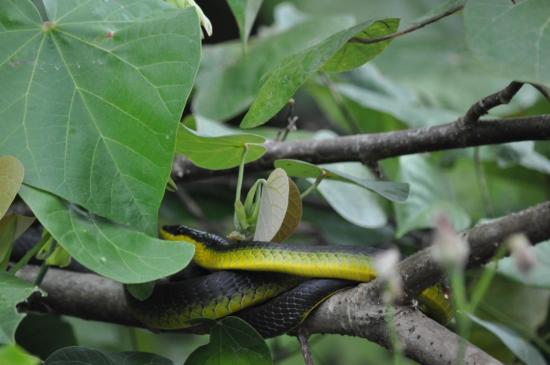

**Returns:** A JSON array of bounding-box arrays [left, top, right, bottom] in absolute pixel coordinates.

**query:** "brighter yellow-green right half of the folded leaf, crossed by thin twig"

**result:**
[[323, 18, 399, 72]]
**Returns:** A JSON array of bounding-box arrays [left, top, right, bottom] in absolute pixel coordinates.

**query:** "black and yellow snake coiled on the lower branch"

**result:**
[[126, 225, 452, 338]]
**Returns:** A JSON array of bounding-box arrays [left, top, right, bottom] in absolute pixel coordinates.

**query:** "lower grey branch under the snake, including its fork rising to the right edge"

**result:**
[[18, 202, 550, 364]]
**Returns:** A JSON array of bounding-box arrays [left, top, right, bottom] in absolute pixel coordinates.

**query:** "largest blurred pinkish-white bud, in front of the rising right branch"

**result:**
[[431, 215, 470, 267]]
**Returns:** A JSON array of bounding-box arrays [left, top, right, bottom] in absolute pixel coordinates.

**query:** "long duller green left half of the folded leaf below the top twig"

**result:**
[[241, 20, 396, 128]]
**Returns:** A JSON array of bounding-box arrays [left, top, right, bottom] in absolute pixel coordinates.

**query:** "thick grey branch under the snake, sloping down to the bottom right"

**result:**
[[17, 266, 500, 365]]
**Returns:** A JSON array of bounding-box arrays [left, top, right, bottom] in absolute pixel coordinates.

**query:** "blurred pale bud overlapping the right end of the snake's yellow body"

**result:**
[[374, 249, 403, 304]]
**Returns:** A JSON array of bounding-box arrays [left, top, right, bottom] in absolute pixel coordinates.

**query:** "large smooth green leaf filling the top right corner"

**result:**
[[464, 0, 550, 86]]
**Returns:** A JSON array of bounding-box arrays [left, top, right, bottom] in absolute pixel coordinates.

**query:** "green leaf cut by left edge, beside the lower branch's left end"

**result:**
[[0, 272, 37, 344]]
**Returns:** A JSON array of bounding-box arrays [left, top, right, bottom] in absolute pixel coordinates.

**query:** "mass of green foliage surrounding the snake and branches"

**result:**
[[0, 0, 550, 365]]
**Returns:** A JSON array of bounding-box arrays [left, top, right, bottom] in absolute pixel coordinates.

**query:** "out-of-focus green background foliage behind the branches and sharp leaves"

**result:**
[[10, 0, 550, 365]]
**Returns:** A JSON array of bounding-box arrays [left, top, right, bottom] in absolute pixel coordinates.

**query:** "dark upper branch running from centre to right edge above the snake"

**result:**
[[172, 115, 550, 182]]
